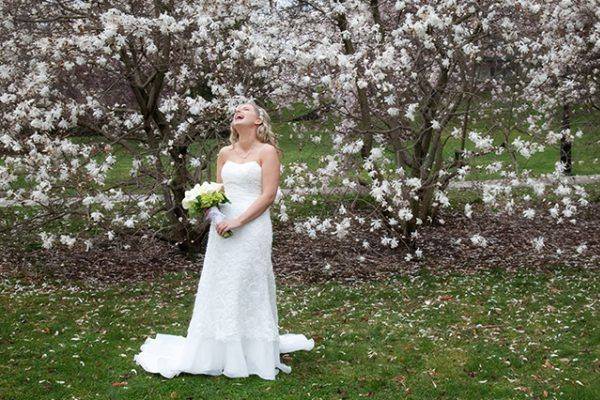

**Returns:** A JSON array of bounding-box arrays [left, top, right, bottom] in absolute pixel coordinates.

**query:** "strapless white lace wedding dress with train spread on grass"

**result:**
[[134, 161, 314, 380]]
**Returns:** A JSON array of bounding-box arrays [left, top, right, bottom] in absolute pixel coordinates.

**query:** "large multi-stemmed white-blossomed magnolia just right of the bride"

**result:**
[[274, 0, 586, 255]]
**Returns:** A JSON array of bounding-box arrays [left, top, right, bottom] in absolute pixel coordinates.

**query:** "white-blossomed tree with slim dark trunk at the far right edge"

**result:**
[[522, 1, 600, 174]]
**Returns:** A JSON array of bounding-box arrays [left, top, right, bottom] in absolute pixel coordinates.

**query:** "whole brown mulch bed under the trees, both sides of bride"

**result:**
[[0, 204, 600, 283]]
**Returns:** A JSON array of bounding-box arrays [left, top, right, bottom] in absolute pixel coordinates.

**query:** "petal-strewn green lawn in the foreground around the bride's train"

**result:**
[[0, 268, 600, 400]]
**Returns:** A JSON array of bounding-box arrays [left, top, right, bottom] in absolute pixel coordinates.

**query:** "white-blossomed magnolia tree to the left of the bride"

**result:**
[[0, 0, 281, 253]]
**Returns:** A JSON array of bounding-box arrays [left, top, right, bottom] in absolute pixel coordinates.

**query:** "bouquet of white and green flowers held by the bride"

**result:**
[[181, 182, 233, 238]]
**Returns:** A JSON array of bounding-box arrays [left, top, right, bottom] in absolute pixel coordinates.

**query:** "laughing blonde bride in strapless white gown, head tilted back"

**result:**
[[134, 103, 314, 380]]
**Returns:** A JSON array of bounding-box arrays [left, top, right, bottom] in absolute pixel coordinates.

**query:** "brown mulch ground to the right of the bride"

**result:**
[[274, 204, 600, 282]]
